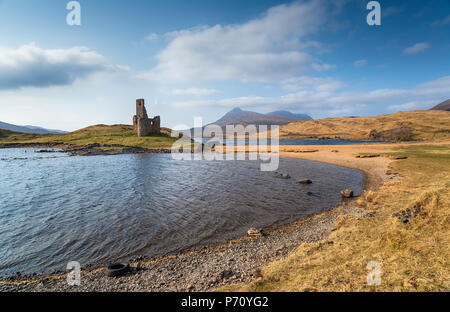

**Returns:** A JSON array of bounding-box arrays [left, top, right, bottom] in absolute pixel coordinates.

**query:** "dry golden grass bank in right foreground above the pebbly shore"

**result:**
[[221, 145, 450, 291]]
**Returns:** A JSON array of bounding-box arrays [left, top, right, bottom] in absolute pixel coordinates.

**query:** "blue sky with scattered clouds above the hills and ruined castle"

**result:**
[[0, 0, 450, 130]]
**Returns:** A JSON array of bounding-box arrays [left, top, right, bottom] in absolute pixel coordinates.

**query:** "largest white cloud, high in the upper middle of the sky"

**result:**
[[139, 1, 327, 82]]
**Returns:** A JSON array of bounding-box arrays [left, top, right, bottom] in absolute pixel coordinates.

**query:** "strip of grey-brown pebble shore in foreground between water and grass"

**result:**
[[0, 200, 374, 292]]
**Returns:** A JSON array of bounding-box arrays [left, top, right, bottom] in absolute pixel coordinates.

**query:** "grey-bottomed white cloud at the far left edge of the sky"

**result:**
[[0, 43, 110, 89]]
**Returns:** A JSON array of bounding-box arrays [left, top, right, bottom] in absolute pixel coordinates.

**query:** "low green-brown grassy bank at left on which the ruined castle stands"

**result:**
[[0, 125, 176, 149]]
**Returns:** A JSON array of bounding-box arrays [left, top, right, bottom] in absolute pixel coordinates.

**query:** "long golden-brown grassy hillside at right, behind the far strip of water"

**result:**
[[280, 110, 450, 140]]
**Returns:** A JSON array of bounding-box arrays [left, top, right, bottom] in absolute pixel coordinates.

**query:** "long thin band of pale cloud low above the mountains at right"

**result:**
[[173, 76, 450, 115]]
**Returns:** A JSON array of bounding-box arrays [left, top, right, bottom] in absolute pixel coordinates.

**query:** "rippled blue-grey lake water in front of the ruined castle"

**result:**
[[0, 149, 364, 276]]
